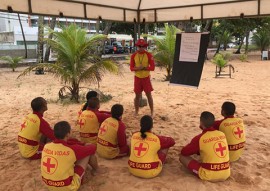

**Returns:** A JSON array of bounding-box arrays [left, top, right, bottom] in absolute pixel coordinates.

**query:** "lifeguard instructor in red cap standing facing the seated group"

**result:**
[[130, 39, 155, 116]]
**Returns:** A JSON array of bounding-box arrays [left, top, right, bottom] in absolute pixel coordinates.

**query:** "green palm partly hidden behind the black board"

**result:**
[[150, 24, 180, 81]]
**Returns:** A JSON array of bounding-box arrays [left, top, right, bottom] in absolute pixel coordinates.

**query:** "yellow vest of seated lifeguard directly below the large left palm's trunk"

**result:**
[[77, 110, 100, 144]]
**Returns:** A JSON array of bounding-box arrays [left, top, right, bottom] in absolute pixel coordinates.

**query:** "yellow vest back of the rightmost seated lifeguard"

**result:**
[[219, 117, 246, 162]]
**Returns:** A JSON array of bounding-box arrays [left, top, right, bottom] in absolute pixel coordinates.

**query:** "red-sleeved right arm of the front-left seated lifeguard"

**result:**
[[69, 144, 97, 160]]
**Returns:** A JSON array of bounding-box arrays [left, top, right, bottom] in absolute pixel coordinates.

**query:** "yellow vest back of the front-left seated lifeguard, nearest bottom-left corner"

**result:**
[[40, 143, 80, 191]]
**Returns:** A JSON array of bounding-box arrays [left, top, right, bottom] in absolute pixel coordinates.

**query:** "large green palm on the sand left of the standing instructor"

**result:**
[[19, 24, 118, 102]]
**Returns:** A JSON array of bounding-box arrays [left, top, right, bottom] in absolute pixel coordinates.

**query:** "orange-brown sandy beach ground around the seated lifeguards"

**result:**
[[0, 52, 270, 191]]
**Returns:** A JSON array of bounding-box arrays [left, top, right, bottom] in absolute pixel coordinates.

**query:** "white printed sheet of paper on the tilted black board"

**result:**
[[179, 33, 201, 62]]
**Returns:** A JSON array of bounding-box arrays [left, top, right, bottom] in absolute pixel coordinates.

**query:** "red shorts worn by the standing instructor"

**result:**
[[134, 76, 154, 93]]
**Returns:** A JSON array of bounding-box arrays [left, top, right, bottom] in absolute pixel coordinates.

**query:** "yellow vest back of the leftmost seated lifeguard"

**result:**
[[18, 114, 42, 158]]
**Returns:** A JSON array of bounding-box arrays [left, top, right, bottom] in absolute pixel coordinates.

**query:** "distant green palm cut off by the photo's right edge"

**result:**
[[252, 29, 270, 52]]
